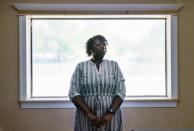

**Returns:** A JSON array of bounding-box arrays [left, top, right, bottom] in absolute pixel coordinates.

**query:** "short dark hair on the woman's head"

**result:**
[[86, 35, 108, 56]]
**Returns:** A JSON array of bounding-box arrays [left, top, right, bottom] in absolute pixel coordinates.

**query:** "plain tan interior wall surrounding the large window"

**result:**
[[0, 0, 194, 131]]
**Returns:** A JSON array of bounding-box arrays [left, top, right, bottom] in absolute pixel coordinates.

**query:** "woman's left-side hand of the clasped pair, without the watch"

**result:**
[[86, 112, 101, 128]]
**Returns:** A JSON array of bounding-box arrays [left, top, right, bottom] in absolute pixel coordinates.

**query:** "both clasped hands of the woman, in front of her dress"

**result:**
[[86, 112, 114, 128]]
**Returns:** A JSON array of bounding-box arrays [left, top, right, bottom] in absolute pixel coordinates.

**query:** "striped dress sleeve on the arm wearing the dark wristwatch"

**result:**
[[115, 62, 126, 100]]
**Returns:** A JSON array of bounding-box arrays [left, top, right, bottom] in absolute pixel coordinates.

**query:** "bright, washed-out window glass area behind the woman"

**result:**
[[32, 15, 166, 97]]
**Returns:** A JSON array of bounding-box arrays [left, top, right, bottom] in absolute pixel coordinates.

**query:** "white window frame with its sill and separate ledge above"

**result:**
[[13, 3, 182, 108]]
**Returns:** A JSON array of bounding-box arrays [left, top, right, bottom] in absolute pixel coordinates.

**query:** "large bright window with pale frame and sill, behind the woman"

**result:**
[[15, 3, 178, 108]]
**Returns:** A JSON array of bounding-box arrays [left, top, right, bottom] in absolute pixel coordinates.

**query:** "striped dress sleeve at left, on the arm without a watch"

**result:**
[[68, 64, 81, 101]]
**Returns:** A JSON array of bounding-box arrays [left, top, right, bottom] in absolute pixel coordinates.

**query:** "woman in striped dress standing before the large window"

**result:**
[[69, 35, 126, 131]]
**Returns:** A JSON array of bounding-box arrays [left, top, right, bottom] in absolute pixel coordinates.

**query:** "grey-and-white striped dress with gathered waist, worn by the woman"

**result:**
[[69, 60, 126, 131]]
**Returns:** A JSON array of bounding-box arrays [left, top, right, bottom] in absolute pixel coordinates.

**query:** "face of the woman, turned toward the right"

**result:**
[[92, 39, 106, 58]]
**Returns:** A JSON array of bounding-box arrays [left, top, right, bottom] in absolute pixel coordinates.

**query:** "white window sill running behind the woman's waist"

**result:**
[[20, 97, 178, 108]]
